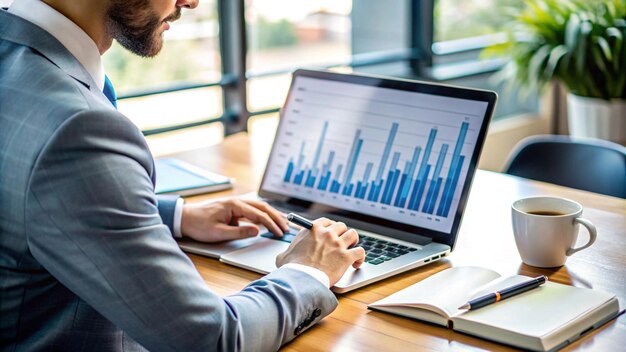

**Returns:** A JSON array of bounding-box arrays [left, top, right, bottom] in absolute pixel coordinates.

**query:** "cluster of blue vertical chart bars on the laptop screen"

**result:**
[[283, 121, 468, 217]]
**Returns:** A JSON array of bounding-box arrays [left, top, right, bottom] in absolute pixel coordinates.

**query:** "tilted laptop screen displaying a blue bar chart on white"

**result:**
[[261, 70, 489, 246]]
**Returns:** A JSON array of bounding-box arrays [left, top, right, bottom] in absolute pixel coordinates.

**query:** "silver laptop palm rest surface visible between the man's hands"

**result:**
[[220, 238, 289, 274]]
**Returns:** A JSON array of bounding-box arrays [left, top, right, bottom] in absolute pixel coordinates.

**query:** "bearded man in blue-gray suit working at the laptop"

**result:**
[[0, 0, 364, 351]]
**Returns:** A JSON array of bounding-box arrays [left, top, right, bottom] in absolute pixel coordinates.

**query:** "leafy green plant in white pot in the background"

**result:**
[[487, 0, 626, 144]]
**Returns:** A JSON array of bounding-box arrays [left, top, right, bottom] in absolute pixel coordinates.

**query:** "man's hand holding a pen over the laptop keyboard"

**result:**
[[276, 218, 365, 286]]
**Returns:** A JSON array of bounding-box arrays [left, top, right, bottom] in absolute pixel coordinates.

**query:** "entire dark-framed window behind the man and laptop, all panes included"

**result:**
[[92, 0, 537, 151]]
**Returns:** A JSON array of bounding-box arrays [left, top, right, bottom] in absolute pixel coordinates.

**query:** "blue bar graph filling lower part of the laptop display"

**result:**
[[282, 121, 469, 217]]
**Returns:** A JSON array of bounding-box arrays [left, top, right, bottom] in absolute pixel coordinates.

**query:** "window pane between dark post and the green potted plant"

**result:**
[[431, 0, 538, 119]]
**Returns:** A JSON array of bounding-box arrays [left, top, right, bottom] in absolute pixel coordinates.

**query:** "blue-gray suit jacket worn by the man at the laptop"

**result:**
[[0, 10, 337, 351]]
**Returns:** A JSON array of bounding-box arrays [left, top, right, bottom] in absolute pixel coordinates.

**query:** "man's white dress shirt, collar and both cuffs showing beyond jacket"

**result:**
[[9, 0, 330, 287]]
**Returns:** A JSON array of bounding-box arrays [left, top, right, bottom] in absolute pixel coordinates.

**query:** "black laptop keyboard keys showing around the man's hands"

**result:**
[[261, 228, 417, 265]]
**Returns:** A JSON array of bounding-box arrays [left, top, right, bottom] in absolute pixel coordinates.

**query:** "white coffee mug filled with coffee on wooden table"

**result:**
[[511, 197, 597, 268]]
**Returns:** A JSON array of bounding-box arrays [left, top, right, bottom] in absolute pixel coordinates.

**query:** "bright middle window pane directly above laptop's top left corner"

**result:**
[[246, 0, 352, 111]]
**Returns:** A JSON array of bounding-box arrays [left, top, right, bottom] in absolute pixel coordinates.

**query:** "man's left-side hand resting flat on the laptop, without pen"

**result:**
[[181, 199, 289, 242]]
